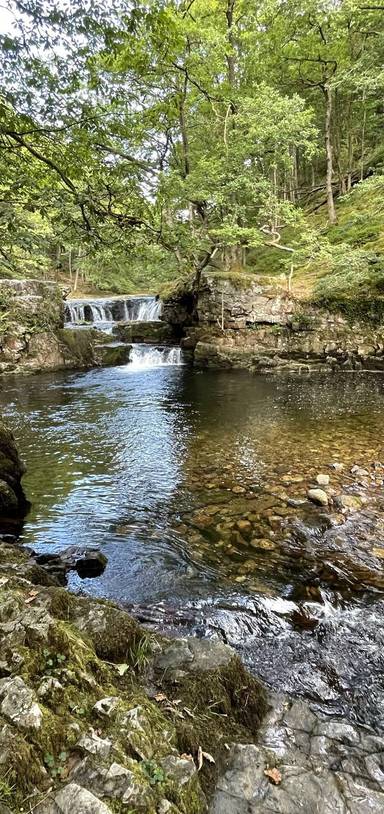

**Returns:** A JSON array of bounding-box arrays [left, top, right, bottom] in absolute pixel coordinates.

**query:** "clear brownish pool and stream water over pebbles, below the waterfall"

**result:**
[[0, 366, 384, 728]]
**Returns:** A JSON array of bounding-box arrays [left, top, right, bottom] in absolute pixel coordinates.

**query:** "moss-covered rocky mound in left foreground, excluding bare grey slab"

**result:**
[[0, 543, 267, 814]]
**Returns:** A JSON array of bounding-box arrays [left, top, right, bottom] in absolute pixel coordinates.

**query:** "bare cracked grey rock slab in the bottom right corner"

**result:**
[[210, 696, 384, 814]]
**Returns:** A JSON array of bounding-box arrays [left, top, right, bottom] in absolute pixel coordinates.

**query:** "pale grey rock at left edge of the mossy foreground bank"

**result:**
[[0, 676, 43, 729]]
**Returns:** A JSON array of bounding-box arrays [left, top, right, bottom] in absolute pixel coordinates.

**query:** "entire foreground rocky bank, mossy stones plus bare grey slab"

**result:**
[[0, 543, 384, 814]]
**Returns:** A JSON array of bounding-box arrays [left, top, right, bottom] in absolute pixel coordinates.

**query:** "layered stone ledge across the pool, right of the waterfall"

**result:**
[[164, 272, 384, 373]]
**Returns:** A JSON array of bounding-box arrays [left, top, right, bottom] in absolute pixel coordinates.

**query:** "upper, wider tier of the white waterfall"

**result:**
[[65, 296, 162, 332]]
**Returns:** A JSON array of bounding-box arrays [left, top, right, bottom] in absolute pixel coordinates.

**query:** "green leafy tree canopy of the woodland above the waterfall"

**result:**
[[0, 0, 384, 291]]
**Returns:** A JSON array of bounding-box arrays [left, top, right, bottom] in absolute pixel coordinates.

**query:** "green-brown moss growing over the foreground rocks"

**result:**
[[0, 546, 266, 814]]
